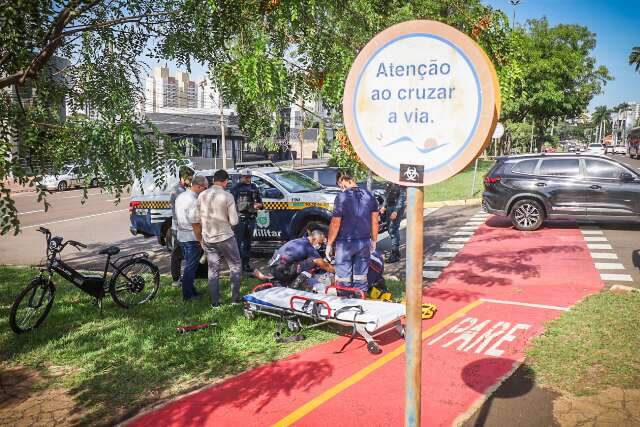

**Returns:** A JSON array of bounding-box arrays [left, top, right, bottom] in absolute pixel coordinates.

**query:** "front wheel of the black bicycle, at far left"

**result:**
[[9, 277, 56, 334]]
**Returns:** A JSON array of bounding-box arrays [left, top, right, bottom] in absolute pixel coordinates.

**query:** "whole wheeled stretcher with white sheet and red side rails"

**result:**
[[244, 283, 405, 354]]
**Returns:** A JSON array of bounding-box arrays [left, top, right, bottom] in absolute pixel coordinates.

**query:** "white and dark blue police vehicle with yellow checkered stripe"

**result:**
[[129, 162, 336, 248]]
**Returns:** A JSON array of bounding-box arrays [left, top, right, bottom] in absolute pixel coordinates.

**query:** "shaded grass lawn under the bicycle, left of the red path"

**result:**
[[0, 267, 402, 424]]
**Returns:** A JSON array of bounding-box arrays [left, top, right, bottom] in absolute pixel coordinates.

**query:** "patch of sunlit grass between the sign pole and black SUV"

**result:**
[[424, 160, 494, 202]]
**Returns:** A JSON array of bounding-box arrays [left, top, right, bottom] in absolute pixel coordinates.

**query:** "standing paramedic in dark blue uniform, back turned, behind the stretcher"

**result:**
[[326, 171, 379, 292]]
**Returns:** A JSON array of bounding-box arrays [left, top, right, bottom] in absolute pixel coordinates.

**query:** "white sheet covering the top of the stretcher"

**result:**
[[244, 287, 405, 333]]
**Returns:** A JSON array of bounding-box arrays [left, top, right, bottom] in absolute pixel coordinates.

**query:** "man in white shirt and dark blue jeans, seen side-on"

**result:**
[[174, 176, 208, 301]]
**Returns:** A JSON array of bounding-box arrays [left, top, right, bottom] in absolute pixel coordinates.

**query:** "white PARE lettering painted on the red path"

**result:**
[[427, 317, 531, 357]]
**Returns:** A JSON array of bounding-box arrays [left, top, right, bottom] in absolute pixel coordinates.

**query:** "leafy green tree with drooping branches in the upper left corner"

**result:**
[[0, 0, 185, 234]]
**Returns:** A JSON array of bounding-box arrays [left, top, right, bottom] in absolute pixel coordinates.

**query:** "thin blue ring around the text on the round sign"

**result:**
[[352, 33, 482, 172]]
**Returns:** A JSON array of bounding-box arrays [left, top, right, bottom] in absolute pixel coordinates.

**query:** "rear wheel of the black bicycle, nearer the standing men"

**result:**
[[109, 259, 160, 308]]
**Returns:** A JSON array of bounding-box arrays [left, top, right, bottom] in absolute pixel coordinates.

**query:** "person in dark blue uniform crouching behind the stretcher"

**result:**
[[269, 230, 335, 288]]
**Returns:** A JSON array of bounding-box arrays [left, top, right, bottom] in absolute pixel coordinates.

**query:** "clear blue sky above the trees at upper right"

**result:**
[[483, 0, 640, 111]]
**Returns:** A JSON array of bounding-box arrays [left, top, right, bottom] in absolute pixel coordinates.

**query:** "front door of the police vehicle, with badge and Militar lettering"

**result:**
[[251, 175, 292, 241]]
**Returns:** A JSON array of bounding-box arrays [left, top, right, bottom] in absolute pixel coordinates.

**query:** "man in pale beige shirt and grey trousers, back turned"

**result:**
[[193, 169, 242, 308]]
